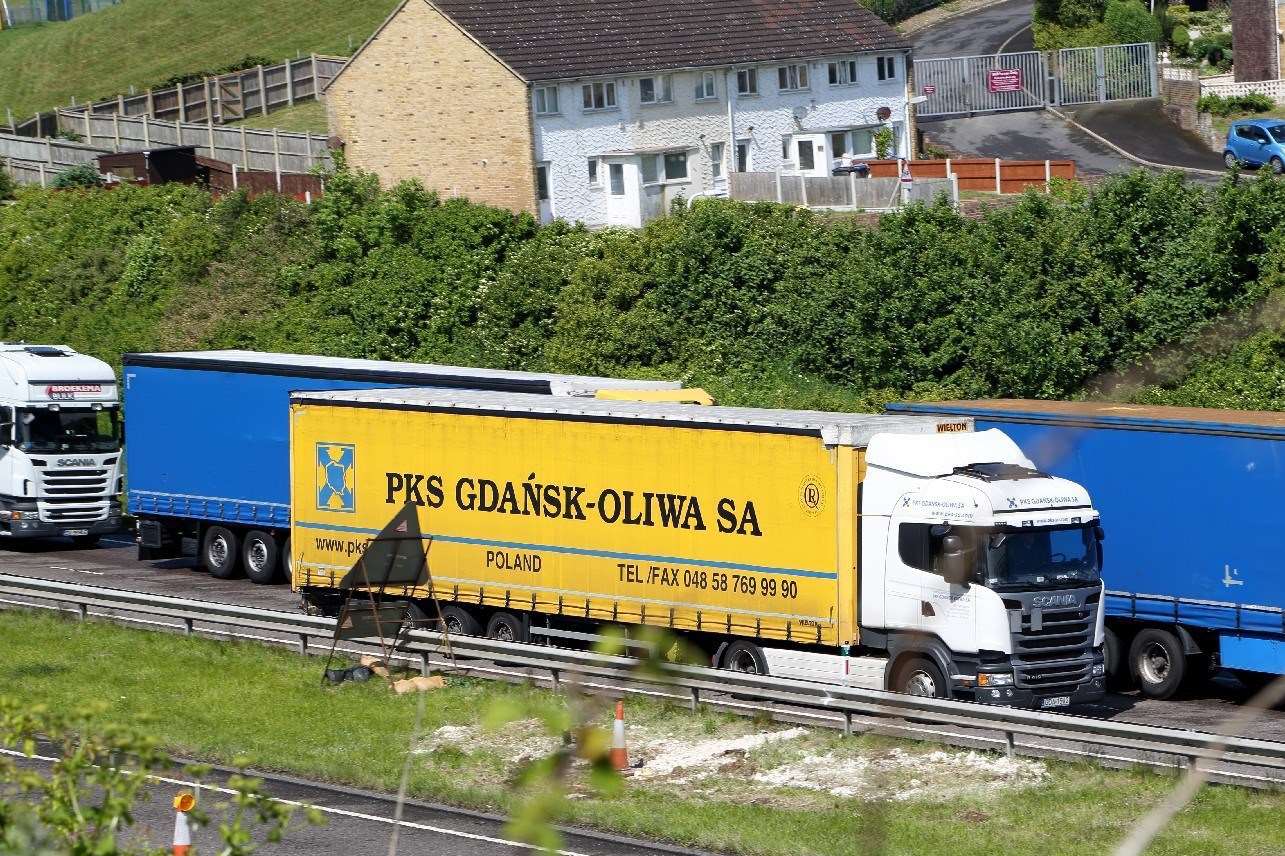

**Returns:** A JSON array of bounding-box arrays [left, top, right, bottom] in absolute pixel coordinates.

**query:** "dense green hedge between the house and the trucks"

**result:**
[[0, 171, 1285, 407]]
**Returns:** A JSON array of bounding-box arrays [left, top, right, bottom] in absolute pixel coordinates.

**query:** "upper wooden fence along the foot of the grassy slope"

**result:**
[[4, 54, 347, 136]]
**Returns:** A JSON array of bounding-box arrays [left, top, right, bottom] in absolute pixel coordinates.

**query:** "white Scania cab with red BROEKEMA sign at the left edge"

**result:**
[[0, 342, 121, 546]]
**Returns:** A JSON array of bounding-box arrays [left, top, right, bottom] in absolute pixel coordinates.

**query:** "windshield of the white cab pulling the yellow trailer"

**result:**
[[983, 524, 1101, 589]]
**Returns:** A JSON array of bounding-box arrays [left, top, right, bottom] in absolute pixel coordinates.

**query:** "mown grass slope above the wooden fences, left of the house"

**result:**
[[0, 0, 396, 117]]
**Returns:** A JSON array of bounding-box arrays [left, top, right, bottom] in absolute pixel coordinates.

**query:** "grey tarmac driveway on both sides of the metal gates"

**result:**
[[914, 0, 1222, 175]]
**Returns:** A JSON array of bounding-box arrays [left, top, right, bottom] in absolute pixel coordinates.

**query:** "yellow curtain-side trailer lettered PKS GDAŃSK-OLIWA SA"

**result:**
[[290, 389, 942, 645]]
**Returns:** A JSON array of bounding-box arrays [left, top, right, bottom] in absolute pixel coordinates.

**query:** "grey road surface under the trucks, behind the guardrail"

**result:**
[[0, 541, 1285, 742]]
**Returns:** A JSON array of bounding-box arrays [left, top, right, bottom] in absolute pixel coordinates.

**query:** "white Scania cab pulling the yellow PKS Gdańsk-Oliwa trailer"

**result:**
[[860, 429, 1104, 708]]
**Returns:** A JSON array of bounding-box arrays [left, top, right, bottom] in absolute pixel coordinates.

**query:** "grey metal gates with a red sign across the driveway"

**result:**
[[915, 44, 1159, 118]]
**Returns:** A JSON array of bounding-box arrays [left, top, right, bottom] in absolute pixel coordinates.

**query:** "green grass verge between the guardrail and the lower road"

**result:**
[[0, 612, 1285, 856]]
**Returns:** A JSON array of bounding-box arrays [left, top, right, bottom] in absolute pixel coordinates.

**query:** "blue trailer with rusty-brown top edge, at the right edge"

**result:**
[[888, 401, 1285, 698]]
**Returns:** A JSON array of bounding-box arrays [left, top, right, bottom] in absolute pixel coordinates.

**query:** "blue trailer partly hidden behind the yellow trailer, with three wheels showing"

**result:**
[[123, 351, 688, 582]]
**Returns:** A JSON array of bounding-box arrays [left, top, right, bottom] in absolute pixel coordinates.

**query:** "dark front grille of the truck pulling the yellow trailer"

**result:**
[[1011, 596, 1099, 693]]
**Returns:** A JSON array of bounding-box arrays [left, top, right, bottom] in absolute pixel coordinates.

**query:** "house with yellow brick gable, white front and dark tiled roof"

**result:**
[[325, 0, 912, 226]]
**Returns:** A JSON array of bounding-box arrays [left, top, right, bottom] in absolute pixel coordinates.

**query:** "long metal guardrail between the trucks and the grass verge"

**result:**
[[0, 573, 1285, 785]]
